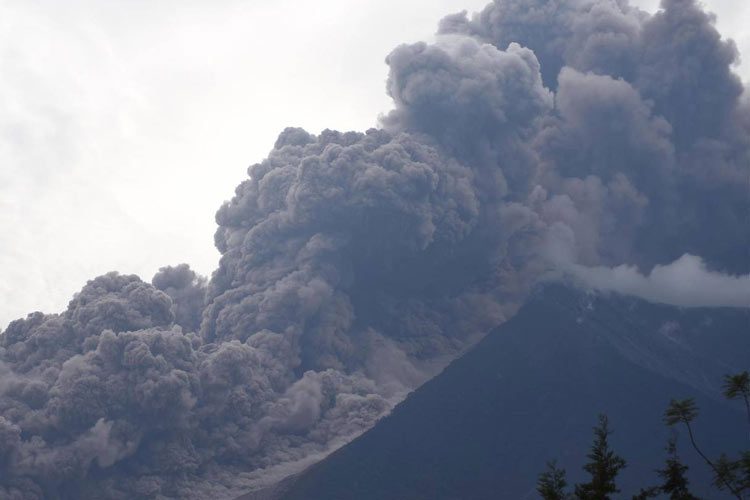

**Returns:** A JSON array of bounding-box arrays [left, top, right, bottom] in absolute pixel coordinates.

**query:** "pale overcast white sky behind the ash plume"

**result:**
[[0, 0, 750, 329]]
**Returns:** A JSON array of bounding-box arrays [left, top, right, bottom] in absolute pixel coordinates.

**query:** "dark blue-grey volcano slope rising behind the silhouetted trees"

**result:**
[[277, 284, 750, 500]]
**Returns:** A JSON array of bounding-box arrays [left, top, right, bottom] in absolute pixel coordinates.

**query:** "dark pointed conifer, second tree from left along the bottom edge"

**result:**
[[575, 414, 626, 500]]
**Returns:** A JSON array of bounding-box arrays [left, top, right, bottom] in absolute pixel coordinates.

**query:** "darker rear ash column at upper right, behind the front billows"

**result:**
[[439, 0, 750, 273]]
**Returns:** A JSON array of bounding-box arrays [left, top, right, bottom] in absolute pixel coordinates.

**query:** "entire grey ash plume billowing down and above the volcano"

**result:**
[[0, 0, 750, 499]]
